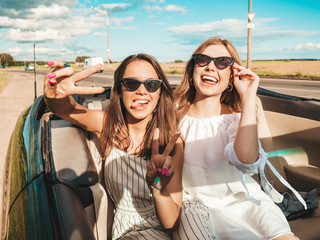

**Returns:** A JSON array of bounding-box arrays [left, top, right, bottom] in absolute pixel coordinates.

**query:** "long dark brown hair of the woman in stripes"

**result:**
[[100, 53, 178, 159]]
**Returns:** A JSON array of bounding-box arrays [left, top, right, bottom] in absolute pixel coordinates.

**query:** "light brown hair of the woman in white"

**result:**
[[174, 37, 241, 120]]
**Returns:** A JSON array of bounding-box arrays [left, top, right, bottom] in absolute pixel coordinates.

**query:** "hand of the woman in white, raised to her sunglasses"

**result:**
[[232, 63, 260, 98]]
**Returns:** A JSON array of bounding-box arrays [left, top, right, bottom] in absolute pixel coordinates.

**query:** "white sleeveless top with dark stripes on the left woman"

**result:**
[[105, 148, 171, 240]]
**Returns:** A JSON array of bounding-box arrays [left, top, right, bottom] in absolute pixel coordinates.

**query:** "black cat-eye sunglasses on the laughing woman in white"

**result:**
[[192, 53, 234, 70]]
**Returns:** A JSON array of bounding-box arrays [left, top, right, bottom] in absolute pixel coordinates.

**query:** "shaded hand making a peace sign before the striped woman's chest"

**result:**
[[146, 128, 180, 191]]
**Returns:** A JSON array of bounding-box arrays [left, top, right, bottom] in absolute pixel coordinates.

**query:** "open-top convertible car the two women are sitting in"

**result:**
[[2, 87, 320, 240]]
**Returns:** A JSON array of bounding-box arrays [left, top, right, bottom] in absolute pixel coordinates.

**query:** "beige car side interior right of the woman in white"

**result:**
[[257, 89, 320, 239]]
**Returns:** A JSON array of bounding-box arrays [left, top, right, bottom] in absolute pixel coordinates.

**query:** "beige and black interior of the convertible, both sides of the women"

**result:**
[[41, 88, 320, 240]]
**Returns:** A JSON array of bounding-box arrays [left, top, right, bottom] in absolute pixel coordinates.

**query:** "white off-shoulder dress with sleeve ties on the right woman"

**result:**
[[180, 113, 306, 239]]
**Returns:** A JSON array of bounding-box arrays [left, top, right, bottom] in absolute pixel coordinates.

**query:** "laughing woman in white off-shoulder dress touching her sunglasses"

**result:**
[[175, 37, 295, 240]]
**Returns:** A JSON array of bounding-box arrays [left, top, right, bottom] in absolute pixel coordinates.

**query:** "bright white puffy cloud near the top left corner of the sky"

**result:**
[[27, 4, 72, 19]]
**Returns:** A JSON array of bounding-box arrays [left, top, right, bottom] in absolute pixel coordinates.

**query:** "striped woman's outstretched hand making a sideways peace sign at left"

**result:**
[[44, 61, 105, 99]]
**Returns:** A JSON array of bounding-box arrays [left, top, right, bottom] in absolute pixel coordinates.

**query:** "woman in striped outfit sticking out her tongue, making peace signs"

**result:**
[[44, 54, 183, 239]]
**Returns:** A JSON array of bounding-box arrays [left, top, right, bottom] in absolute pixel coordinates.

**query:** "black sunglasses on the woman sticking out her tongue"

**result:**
[[121, 78, 162, 92]]
